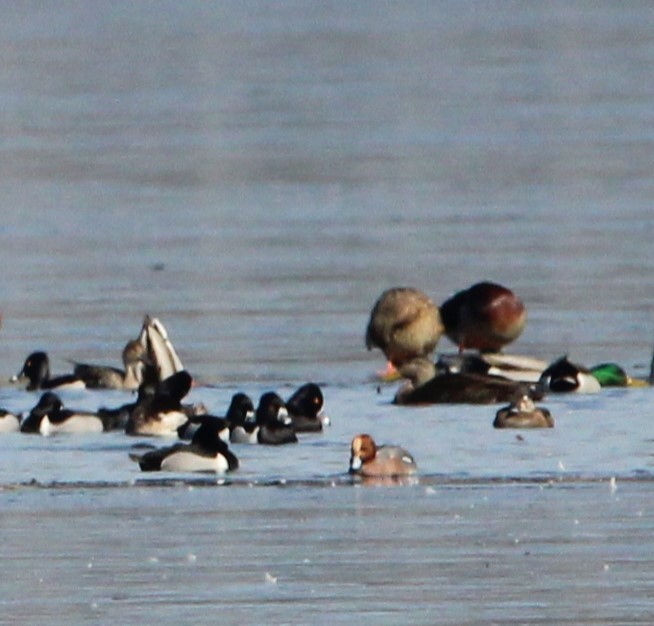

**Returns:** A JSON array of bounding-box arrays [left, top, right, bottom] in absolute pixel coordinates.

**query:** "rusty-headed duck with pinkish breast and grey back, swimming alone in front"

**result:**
[[349, 434, 418, 477]]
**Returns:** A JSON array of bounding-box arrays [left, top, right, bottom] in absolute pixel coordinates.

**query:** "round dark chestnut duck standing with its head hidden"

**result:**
[[439, 281, 527, 352]]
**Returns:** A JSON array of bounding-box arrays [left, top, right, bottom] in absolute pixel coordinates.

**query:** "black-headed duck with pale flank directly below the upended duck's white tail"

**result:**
[[125, 370, 193, 437]]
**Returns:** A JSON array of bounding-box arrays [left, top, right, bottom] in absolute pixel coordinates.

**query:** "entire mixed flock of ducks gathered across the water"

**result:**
[[0, 282, 653, 477]]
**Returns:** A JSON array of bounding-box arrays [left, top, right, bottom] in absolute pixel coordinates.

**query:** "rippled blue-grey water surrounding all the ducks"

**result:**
[[0, 0, 654, 624]]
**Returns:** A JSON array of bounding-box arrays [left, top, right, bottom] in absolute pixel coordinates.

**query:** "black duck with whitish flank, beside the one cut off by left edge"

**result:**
[[20, 391, 120, 436]]
